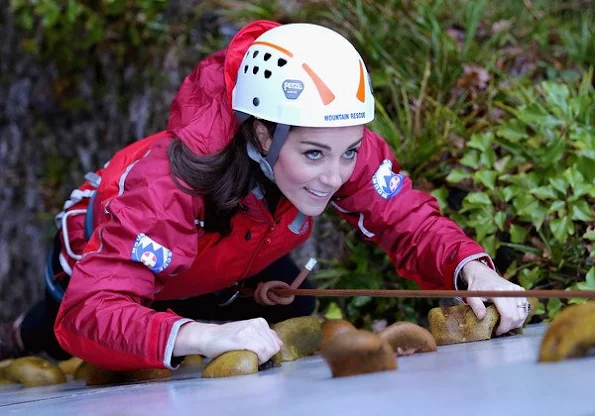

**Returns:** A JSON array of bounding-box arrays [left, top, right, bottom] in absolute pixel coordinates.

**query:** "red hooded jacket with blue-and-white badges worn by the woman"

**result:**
[[55, 21, 492, 370]]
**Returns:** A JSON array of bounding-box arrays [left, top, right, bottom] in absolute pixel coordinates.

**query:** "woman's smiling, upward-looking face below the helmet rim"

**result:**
[[263, 126, 364, 216]]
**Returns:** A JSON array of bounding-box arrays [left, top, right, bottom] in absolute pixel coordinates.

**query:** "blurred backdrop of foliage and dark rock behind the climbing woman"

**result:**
[[0, 0, 595, 328]]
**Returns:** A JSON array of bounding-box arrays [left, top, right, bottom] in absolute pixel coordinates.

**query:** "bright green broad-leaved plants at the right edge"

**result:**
[[441, 71, 595, 317]]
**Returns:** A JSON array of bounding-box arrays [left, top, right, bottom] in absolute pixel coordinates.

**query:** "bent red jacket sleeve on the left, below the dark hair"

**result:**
[[54, 144, 197, 370]]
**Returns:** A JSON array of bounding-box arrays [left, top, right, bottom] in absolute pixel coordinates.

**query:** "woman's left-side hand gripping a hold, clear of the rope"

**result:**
[[173, 318, 283, 364]]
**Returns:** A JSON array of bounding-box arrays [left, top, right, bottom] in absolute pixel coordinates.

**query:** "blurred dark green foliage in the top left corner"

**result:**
[[10, 0, 167, 71]]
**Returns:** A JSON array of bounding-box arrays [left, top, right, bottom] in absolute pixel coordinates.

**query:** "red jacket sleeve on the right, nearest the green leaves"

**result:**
[[331, 129, 494, 289]]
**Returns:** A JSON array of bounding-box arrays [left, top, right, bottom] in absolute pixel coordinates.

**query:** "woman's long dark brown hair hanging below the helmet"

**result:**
[[168, 117, 275, 235]]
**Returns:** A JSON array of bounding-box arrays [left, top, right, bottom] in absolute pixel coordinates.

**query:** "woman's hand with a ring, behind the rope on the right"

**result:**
[[462, 261, 529, 335]]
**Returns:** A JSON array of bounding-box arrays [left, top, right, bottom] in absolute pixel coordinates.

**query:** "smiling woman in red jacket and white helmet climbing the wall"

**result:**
[[0, 21, 527, 370]]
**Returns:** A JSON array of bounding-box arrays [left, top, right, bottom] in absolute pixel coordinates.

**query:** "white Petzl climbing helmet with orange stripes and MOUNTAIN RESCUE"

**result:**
[[232, 23, 374, 127]]
